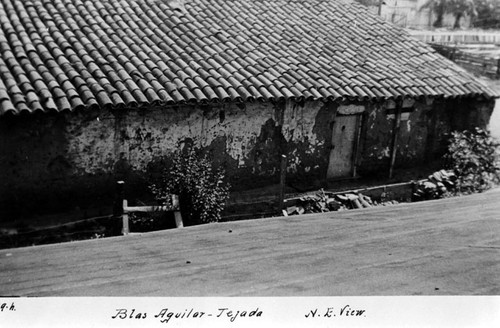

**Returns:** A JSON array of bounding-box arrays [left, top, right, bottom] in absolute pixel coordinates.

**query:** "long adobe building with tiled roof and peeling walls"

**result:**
[[0, 0, 498, 221]]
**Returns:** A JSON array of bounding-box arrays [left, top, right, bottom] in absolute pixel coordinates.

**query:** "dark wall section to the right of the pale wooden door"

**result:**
[[358, 99, 494, 176]]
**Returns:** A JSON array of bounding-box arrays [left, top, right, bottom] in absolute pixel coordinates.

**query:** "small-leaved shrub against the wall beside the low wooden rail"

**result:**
[[150, 145, 229, 225]]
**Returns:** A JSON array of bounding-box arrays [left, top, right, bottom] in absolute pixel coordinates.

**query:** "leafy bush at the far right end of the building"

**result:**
[[445, 128, 500, 194]]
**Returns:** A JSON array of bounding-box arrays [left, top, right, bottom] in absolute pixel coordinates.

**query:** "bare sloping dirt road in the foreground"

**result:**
[[0, 187, 500, 296]]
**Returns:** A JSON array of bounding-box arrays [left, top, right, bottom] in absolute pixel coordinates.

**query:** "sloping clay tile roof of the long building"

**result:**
[[0, 0, 499, 115]]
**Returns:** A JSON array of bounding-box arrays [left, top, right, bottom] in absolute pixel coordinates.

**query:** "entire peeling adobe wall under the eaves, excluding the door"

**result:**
[[0, 96, 493, 224]]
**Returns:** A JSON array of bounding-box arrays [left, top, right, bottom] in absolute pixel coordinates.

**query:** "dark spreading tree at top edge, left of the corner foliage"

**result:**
[[419, 0, 477, 29]]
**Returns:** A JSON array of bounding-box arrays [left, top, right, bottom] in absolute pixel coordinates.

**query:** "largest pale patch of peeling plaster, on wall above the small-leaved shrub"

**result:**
[[67, 104, 273, 173]]
